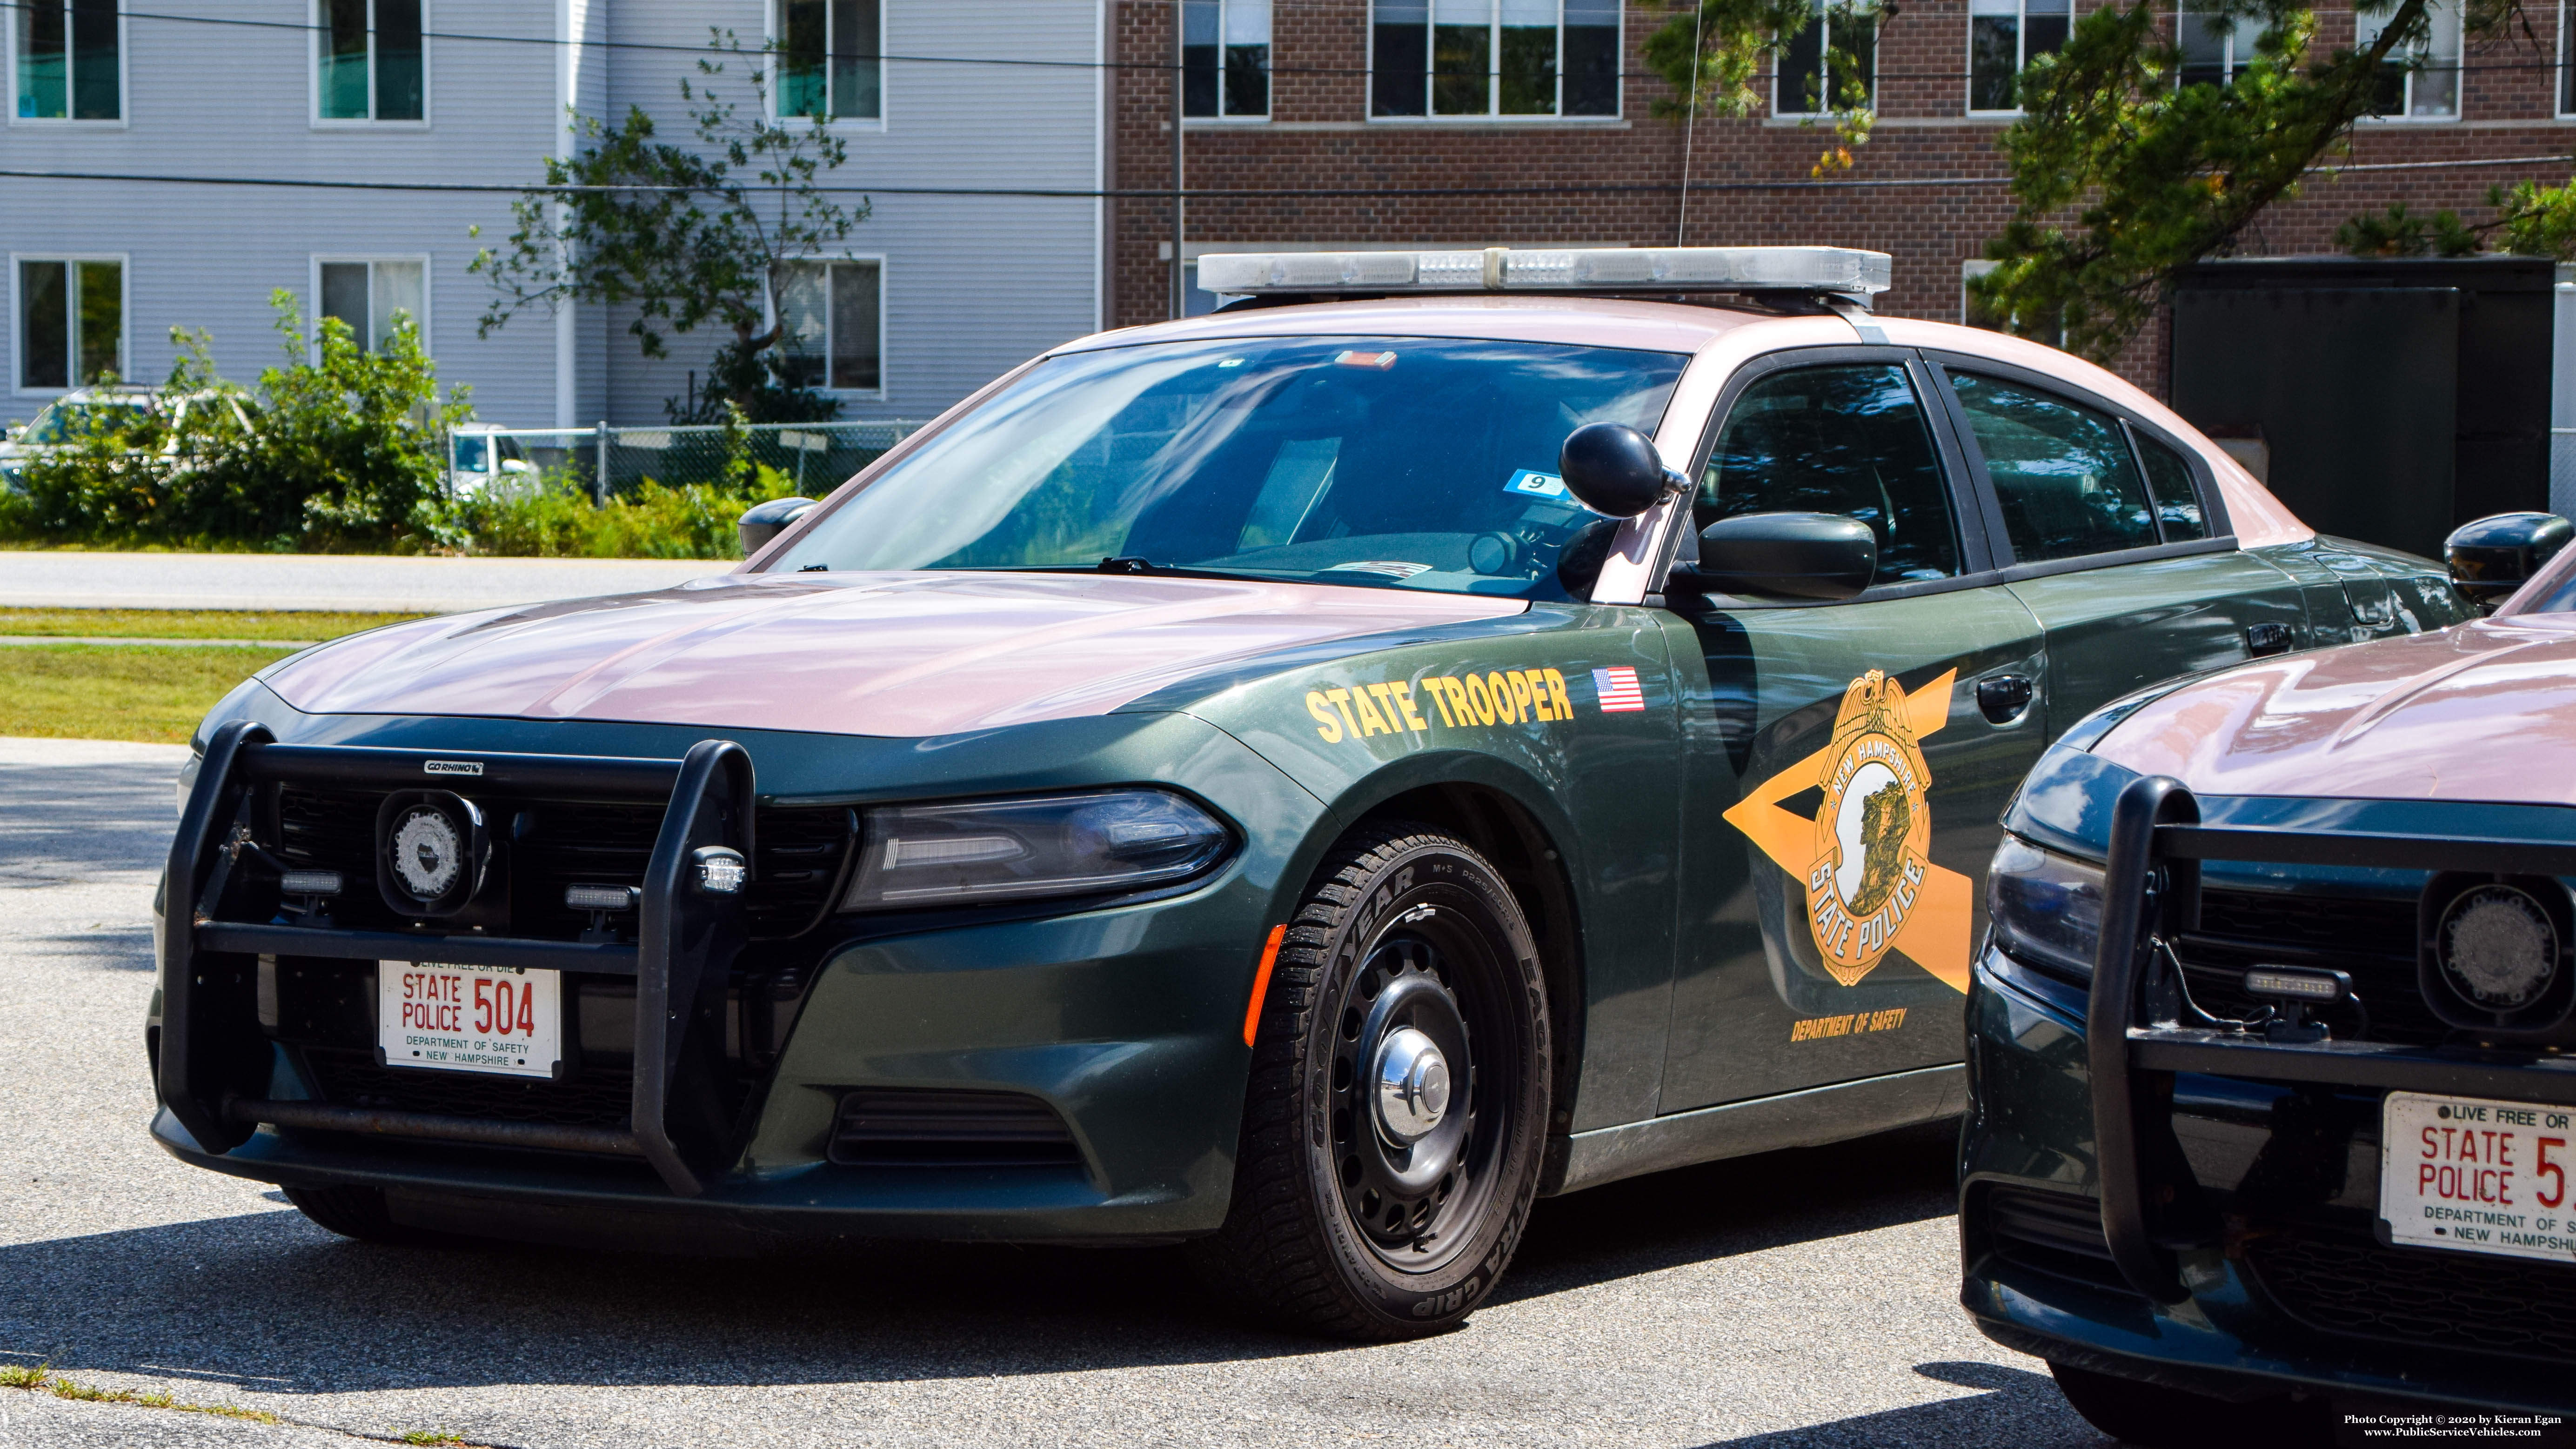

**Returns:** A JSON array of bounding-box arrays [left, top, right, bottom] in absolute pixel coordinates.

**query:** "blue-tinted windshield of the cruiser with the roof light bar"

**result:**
[[773, 337, 1687, 597]]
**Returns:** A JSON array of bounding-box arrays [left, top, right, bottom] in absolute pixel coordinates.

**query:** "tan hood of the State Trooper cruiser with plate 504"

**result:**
[[263, 574, 1527, 736]]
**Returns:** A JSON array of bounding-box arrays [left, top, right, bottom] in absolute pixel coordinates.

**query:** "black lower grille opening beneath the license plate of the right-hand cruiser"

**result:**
[[2246, 1233, 2576, 1364]]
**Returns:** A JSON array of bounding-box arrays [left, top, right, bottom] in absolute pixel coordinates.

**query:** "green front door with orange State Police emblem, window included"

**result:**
[[1661, 350, 2043, 1112]]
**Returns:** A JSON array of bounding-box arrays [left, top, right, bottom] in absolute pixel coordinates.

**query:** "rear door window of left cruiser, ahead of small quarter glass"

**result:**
[[1950, 373, 2159, 564]]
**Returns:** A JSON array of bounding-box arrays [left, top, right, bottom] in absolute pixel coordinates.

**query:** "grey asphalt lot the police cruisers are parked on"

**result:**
[[0, 741, 2105, 1449]]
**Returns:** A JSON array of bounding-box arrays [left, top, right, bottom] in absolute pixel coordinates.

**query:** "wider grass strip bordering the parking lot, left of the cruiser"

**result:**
[[0, 643, 294, 744]]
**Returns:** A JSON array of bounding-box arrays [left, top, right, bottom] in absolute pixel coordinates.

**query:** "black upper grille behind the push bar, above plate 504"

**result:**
[[278, 785, 858, 939]]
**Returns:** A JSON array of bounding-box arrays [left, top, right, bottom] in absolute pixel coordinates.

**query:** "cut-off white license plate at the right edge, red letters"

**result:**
[[2380, 1091, 2576, 1264]]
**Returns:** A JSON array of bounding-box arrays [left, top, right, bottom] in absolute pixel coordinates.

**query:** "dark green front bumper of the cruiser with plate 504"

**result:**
[[152, 694, 1324, 1246]]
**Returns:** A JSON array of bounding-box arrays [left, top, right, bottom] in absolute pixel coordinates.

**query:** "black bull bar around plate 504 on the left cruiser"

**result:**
[[157, 721, 755, 1197]]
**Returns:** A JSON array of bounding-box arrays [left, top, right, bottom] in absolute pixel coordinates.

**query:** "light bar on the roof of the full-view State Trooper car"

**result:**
[[1198, 247, 1891, 299]]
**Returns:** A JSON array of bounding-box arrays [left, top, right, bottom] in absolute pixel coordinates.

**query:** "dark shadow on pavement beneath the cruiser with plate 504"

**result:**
[[0, 1127, 1950, 1392]]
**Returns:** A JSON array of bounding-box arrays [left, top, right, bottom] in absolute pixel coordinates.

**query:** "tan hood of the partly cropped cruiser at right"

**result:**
[[2094, 615, 2576, 806]]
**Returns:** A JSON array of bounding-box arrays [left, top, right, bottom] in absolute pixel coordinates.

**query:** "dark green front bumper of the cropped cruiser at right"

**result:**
[[1960, 947, 2576, 1416]]
